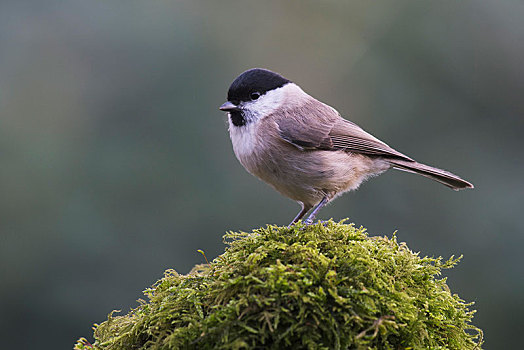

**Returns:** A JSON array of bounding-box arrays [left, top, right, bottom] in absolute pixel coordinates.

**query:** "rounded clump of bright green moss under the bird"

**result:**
[[75, 221, 482, 350]]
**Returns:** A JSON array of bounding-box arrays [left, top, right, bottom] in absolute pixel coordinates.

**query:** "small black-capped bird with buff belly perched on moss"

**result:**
[[220, 68, 473, 225]]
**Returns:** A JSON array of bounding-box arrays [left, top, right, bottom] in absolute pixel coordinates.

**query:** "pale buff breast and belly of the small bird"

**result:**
[[231, 125, 389, 205]]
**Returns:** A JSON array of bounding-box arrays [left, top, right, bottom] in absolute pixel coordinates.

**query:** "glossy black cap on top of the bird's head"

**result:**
[[227, 68, 291, 103]]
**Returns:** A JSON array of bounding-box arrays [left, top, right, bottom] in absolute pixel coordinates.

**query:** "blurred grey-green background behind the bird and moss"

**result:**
[[0, 0, 524, 349]]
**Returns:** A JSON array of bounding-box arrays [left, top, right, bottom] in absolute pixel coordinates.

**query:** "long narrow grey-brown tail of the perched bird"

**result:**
[[388, 159, 473, 191]]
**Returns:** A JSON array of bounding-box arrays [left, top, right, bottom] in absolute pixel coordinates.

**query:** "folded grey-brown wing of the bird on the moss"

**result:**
[[275, 106, 413, 161]]
